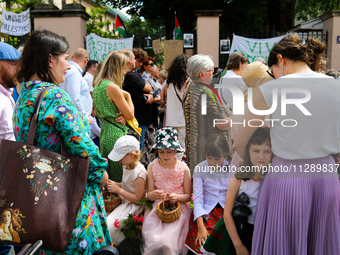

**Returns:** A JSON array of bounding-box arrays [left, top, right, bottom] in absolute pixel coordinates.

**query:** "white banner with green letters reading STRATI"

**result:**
[[85, 33, 133, 62]]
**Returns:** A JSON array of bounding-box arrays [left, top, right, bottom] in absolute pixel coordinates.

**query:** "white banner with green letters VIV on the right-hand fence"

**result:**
[[230, 35, 285, 62]]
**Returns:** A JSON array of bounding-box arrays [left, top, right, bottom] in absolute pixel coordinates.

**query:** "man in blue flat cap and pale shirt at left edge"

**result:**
[[0, 42, 21, 254]]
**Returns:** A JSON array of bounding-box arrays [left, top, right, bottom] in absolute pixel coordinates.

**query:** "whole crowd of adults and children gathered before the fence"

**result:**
[[0, 27, 340, 255]]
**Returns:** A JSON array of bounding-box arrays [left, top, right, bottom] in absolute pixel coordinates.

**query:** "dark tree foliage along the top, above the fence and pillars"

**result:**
[[100, 0, 340, 35]]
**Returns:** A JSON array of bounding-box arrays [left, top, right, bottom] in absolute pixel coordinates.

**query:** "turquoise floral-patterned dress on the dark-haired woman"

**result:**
[[13, 81, 111, 255]]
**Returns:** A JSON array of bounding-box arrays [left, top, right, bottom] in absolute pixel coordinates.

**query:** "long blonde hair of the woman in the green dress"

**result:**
[[94, 51, 129, 88]]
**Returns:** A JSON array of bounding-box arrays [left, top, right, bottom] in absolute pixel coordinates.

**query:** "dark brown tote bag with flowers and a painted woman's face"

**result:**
[[0, 88, 90, 251]]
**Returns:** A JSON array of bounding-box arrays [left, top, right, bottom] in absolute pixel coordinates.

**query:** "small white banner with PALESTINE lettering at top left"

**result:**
[[0, 8, 31, 36]]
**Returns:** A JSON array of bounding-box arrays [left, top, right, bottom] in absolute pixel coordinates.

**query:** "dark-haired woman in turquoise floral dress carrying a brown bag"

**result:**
[[13, 30, 111, 254]]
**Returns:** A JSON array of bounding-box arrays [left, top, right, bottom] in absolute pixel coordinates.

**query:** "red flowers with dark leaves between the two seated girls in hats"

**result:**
[[114, 213, 144, 238]]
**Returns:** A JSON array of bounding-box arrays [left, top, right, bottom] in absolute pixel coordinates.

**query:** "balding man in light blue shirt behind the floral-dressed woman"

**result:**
[[59, 48, 92, 120]]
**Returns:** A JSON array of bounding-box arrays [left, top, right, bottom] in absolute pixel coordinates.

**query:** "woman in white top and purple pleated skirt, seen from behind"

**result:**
[[234, 35, 340, 255]]
